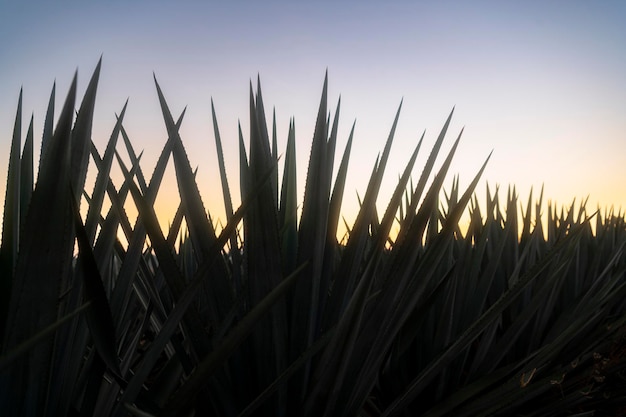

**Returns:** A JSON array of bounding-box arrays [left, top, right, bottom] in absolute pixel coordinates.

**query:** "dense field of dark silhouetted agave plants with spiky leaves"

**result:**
[[0, 59, 626, 417]]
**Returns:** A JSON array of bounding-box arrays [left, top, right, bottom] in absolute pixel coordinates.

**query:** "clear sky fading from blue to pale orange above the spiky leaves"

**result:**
[[0, 0, 626, 239]]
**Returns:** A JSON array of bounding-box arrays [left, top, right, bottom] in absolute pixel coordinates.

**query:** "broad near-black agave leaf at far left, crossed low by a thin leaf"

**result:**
[[0, 72, 76, 416]]
